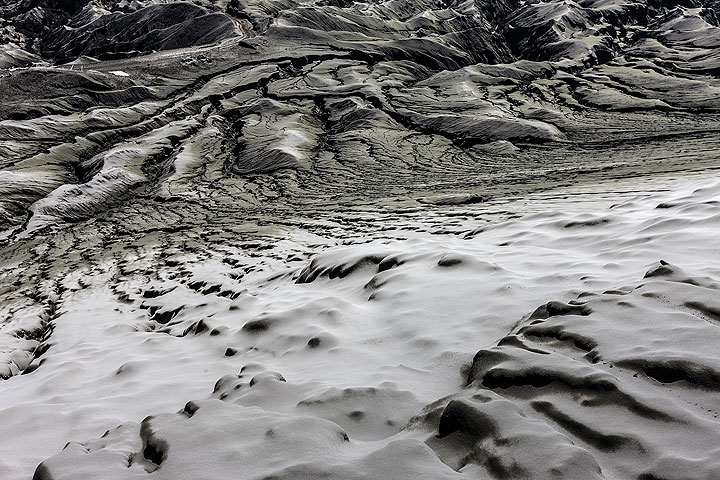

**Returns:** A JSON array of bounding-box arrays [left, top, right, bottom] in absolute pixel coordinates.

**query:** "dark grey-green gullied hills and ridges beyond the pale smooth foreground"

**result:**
[[0, 0, 720, 236]]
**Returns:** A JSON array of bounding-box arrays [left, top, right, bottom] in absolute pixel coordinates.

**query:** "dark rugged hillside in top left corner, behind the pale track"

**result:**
[[0, 0, 239, 57]]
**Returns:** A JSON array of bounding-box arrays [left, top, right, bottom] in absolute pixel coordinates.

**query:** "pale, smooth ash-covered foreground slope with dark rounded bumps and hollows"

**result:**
[[0, 171, 720, 480]]
